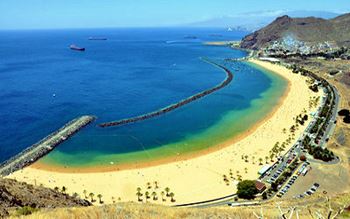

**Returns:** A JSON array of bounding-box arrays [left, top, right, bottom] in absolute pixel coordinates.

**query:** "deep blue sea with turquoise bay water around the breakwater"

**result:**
[[0, 28, 285, 166]]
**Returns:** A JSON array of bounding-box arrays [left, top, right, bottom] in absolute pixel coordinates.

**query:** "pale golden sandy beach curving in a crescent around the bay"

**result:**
[[9, 60, 320, 205]]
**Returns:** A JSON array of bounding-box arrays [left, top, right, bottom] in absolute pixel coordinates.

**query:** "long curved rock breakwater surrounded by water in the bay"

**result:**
[[98, 58, 233, 128]]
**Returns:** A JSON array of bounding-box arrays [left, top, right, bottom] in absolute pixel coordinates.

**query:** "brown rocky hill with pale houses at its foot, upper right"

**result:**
[[241, 13, 350, 49]]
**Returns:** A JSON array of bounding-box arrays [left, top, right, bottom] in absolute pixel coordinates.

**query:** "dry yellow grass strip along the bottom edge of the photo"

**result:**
[[13, 194, 350, 219]]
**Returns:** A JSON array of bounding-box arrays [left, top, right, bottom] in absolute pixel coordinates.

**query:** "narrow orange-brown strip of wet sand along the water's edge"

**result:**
[[30, 61, 291, 173]]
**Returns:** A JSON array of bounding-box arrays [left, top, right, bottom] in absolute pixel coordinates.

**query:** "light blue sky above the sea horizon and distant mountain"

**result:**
[[0, 0, 350, 29]]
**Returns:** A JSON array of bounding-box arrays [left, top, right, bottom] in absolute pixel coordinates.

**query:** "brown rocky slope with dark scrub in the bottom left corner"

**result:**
[[0, 178, 91, 218]]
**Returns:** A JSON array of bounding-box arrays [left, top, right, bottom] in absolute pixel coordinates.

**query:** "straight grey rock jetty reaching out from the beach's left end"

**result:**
[[0, 116, 95, 176]]
